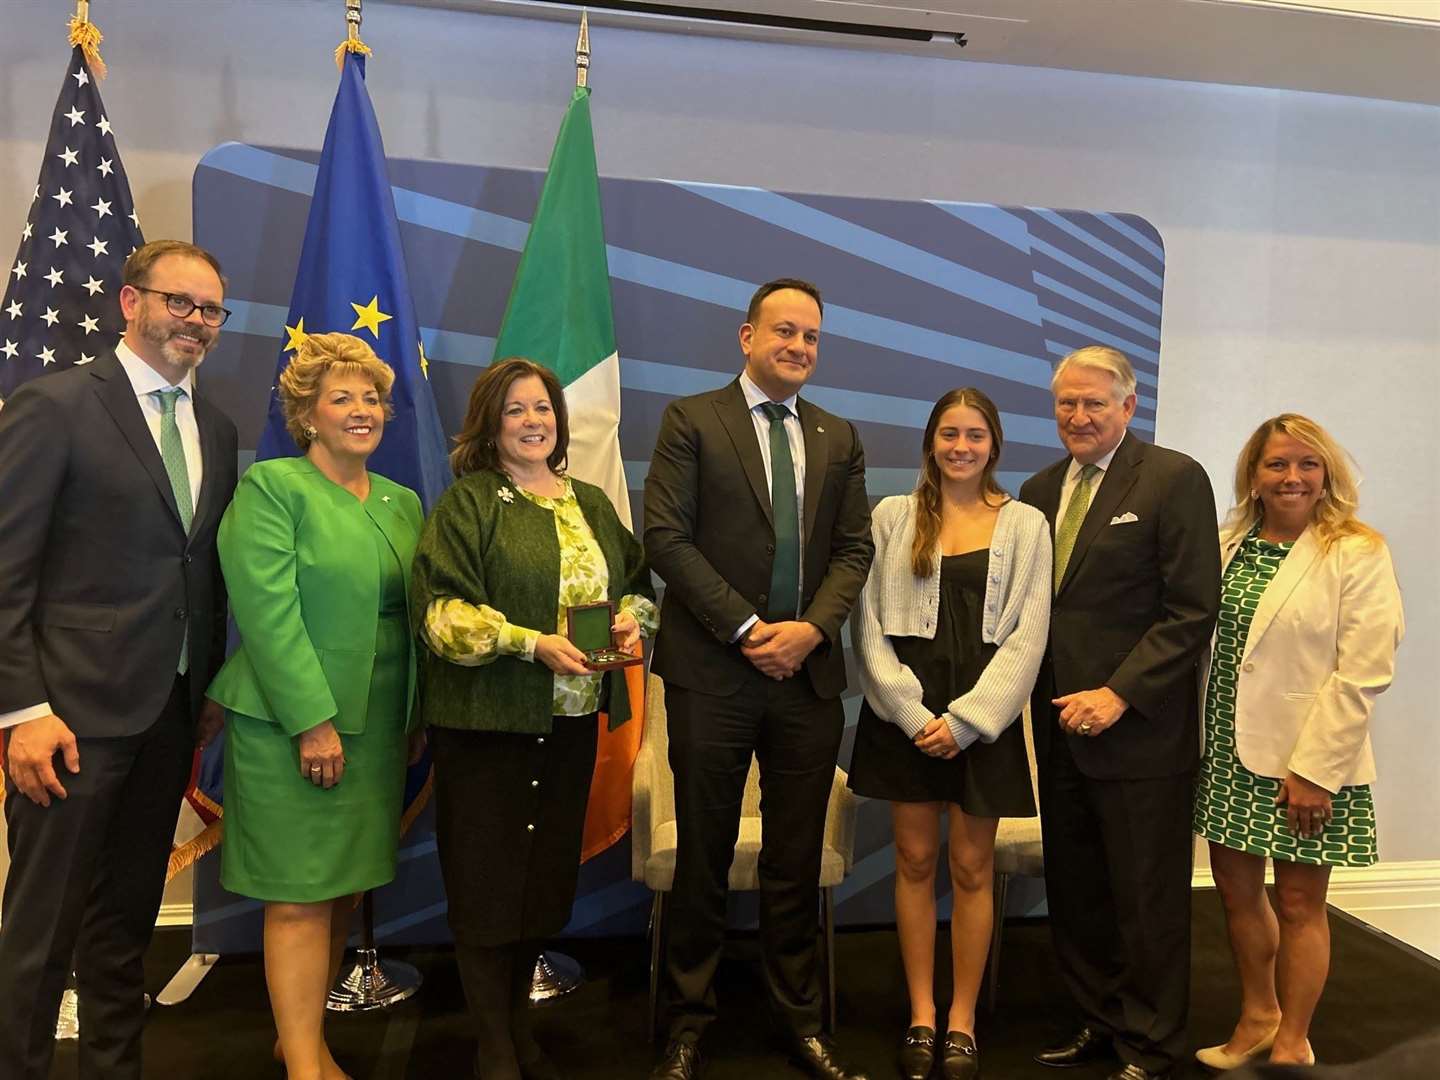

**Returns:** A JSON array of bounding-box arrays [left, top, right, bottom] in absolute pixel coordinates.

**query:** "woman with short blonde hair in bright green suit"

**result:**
[[209, 334, 423, 1080]]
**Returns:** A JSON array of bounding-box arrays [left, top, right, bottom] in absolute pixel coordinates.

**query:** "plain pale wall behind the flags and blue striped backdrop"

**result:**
[[0, 0, 1440, 887]]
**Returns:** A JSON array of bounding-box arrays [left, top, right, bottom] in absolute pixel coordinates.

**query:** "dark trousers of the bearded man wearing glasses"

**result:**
[[0, 677, 194, 1080]]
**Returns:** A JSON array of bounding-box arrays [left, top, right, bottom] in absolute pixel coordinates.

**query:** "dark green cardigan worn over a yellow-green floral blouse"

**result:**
[[410, 469, 655, 734]]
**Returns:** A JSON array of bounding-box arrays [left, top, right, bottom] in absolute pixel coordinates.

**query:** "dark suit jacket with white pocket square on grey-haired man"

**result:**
[[1020, 435, 1220, 779]]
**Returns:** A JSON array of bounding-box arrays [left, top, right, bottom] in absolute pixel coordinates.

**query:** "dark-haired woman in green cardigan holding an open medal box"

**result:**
[[410, 359, 658, 1080]]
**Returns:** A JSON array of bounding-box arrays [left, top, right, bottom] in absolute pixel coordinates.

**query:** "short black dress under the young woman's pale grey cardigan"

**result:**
[[850, 549, 1035, 818]]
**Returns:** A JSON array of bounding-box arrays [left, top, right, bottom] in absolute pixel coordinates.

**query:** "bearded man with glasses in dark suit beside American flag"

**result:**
[[0, 240, 236, 1080]]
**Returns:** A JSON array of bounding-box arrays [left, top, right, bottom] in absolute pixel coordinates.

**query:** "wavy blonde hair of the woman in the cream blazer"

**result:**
[[1225, 412, 1380, 552]]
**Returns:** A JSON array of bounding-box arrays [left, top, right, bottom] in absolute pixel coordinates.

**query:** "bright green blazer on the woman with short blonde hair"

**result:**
[[209, 458, 425, 736]]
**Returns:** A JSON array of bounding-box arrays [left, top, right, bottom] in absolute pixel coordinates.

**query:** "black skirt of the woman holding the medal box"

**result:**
[[429, 713, 599, 946]]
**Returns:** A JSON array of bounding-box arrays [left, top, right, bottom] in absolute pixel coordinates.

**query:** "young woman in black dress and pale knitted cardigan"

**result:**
[[850, 387, 1051, 1080]]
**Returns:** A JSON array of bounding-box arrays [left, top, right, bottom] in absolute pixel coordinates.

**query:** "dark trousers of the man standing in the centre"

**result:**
[[665, 672, 845, 1041]]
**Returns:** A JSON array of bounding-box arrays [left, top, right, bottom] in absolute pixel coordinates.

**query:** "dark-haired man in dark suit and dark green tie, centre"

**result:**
[[644, 278, 874, 1080]]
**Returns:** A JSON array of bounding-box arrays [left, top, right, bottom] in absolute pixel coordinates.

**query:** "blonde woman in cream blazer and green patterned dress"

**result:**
[[1195, 413, 1404, 1068]]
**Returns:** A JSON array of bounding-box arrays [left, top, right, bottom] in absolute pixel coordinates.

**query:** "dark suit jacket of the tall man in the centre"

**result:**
[[644, 380, 874, 698]]
